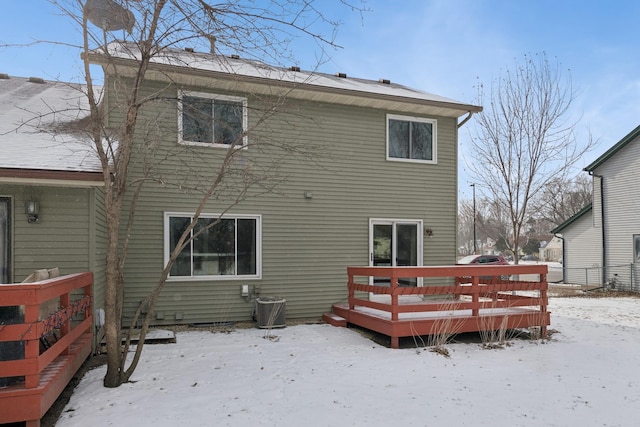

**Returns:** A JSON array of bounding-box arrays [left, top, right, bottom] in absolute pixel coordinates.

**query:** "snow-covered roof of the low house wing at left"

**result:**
[[0, 75, 102, 172]]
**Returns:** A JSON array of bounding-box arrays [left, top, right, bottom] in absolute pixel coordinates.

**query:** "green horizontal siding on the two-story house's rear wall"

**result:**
[[108, 76, 457, 324]]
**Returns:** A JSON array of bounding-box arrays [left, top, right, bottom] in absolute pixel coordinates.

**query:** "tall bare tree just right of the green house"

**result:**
[[468, 53, 594, 262]]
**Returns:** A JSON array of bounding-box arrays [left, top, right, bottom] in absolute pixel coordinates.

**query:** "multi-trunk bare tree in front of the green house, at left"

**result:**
[[43, 0, 362, 387]]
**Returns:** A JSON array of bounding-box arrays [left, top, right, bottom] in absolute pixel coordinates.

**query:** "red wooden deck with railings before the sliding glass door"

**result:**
[[323, 265, 550, 348]]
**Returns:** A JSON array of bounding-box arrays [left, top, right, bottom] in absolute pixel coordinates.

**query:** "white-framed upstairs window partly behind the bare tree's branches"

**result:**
[[178, 91, 247, 148]]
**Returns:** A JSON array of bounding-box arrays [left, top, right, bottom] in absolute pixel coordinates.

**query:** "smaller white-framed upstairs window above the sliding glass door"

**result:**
[[387, 114, 437, 163]]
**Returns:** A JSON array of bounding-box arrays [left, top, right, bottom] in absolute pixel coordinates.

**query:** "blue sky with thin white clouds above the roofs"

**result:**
[[0, 0, 640, 198]]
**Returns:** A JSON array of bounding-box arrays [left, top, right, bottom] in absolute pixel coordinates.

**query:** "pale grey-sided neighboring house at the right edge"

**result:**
[[553, 126, 640, 290]]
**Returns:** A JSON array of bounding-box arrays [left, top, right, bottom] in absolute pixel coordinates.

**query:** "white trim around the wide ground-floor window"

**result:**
[[163, 212, 262, 282]]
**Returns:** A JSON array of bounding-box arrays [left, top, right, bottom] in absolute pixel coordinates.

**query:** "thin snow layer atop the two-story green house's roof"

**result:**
[[101, 42, 481, 111]]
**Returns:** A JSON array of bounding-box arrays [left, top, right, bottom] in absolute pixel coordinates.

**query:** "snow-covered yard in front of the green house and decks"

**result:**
[[56, 298, 640, 427]]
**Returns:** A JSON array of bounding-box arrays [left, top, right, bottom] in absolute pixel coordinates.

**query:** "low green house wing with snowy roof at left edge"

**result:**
[[0, 74, 104, 307]]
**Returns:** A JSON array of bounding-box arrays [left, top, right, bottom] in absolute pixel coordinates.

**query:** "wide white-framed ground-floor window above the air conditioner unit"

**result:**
[[164, 212, 262, 280]]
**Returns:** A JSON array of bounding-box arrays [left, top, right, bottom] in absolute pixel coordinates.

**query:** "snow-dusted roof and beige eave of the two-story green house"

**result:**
[[89, 42, 482, 117]]
